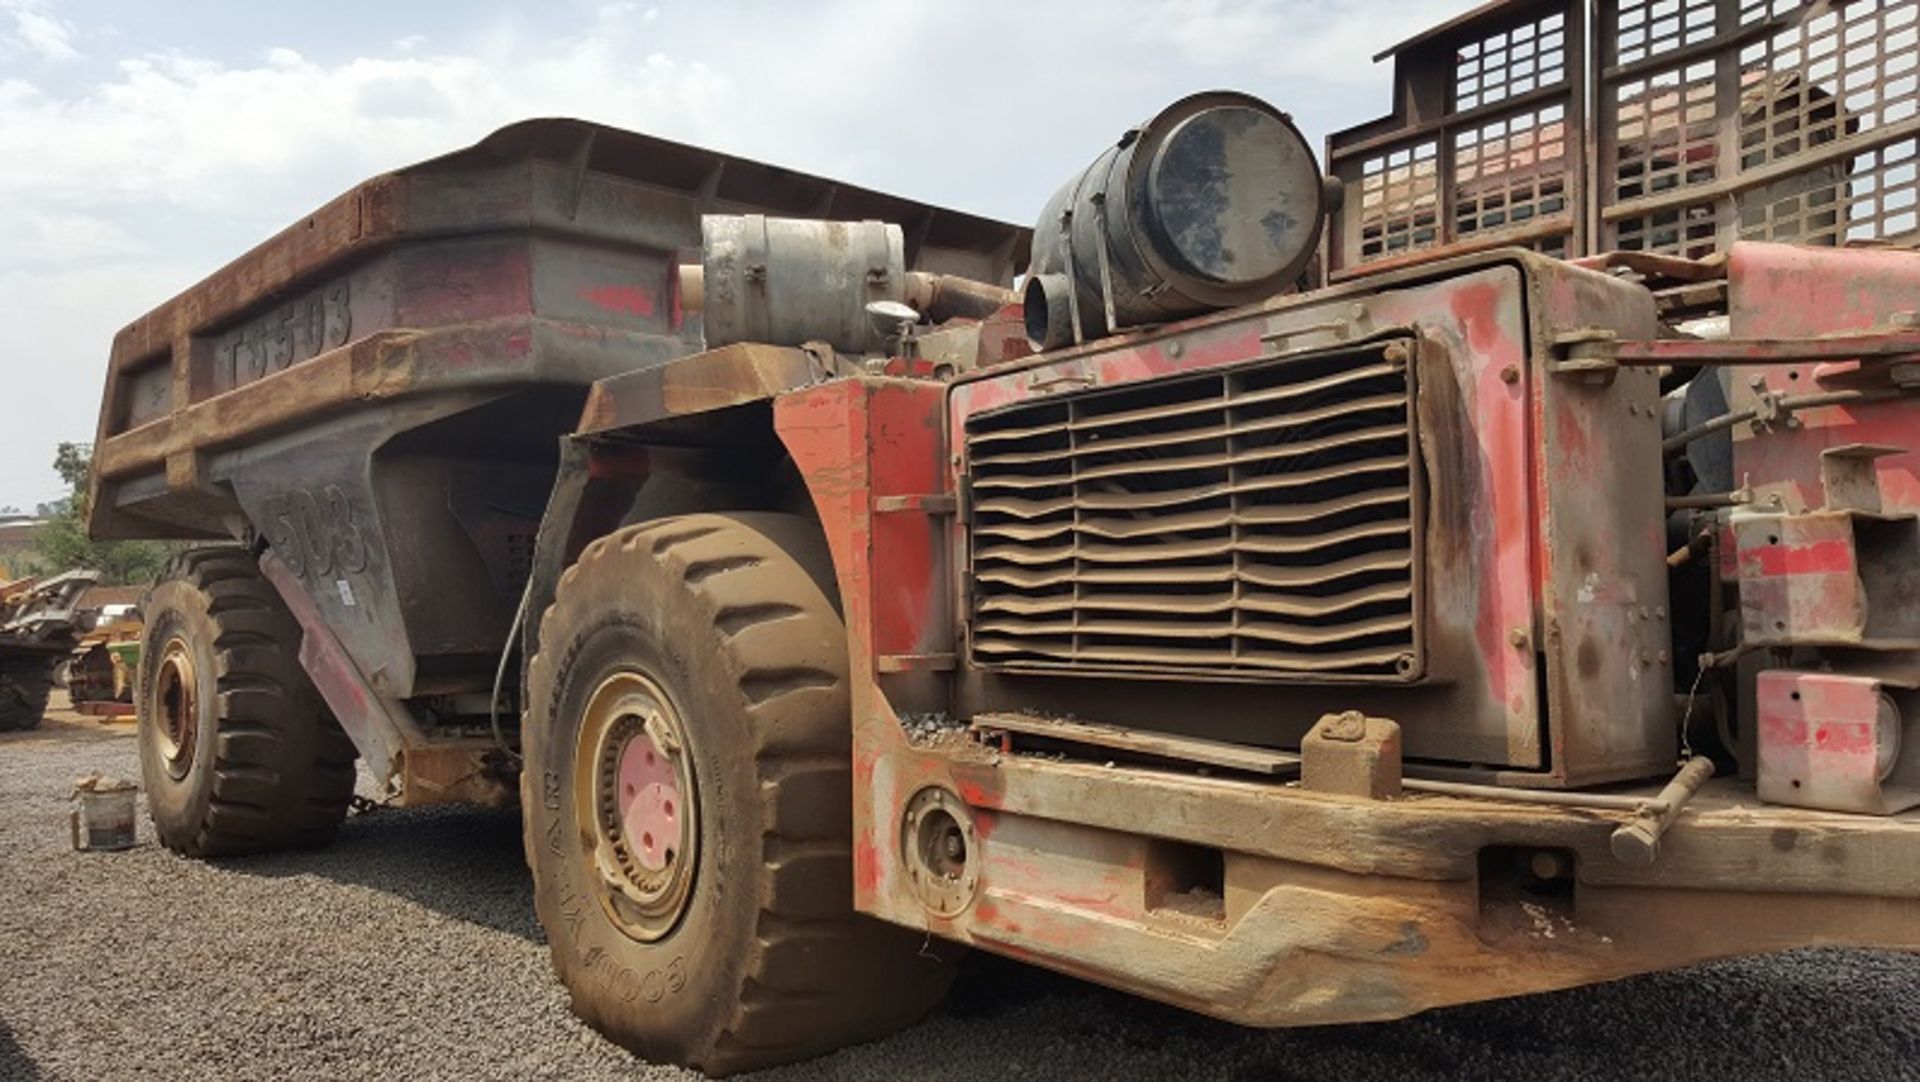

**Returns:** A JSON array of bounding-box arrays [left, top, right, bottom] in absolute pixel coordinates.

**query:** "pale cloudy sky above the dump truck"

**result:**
[[0, 0, 1473, 510]]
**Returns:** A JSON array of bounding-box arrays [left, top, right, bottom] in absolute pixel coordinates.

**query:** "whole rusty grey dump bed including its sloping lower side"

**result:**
[[90, 121, 1025, 698]]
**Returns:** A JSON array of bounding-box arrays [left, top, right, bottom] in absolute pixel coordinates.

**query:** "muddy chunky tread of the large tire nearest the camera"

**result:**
[[520, 514, 952, 1074]]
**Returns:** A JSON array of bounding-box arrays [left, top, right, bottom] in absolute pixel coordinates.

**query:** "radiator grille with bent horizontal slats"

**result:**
[[966, 341, 1421, 681]]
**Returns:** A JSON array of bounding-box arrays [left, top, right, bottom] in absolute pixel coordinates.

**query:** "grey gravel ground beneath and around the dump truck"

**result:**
[[0, 709, 1920, 1082]]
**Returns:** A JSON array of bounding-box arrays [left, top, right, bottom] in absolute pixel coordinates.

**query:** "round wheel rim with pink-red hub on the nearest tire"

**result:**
[[574, 671, 699, 942]]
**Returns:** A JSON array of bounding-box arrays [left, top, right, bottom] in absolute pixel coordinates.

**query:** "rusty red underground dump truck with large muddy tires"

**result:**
[[92, 25, 1920, 1072]]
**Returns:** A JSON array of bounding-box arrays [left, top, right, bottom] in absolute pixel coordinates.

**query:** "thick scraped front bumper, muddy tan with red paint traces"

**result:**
[[875, 742, 1920, 1026]]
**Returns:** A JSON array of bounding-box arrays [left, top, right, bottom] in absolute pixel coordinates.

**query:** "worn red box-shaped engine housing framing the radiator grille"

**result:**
[[948, 255, 1674, 785]]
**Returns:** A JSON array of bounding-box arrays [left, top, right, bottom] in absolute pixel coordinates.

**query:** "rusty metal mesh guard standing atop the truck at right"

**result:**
[[1327, 0, 1920, 276]]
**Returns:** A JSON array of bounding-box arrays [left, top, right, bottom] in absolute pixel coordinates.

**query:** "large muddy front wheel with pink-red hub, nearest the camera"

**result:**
[[520, 514, 952, 1074]]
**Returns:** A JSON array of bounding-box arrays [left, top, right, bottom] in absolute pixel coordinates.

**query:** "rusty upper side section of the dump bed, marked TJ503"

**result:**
[[90, 119, 1027, 537]]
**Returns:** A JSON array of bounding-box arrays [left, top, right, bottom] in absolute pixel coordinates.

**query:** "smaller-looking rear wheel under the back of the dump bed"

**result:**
[[134, 549, 353, 856]]
